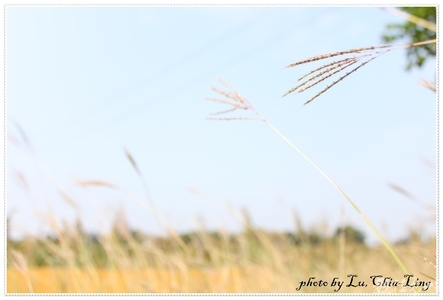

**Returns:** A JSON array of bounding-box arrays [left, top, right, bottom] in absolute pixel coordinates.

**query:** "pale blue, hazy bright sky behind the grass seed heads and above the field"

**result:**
[[6, 6, 437, 246]]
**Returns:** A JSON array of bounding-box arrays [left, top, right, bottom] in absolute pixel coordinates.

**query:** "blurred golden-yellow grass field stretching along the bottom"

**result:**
[[7, 207, 436, 293]]
